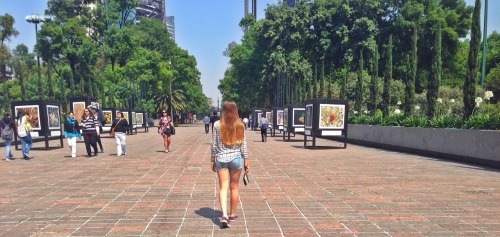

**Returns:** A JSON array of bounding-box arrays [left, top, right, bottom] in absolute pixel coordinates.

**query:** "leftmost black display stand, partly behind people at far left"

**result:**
[[11, 100, 64, 150]]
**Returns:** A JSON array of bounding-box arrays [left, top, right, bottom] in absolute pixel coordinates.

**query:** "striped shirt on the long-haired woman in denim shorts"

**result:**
[[212, 121, 248, 163]]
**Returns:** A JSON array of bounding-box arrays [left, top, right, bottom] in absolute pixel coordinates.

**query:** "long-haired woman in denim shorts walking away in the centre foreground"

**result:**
[[210, 101, 249, 228]]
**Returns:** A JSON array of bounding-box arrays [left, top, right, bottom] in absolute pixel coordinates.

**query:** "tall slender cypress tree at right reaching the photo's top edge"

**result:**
[[463, 0, 481, 118]]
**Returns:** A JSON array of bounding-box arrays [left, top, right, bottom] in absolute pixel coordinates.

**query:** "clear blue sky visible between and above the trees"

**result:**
[[0, 0, 500, 105]]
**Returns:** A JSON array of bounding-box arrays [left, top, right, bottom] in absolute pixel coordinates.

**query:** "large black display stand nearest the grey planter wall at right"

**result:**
[[304, 99, 349, 149]]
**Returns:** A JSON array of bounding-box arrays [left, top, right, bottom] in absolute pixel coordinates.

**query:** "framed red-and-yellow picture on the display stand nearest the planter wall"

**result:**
[[319, 104, 345, 129]]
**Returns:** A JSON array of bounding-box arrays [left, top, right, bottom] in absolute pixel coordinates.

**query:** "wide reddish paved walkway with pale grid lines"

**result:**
[[0, 122, 500, 237]]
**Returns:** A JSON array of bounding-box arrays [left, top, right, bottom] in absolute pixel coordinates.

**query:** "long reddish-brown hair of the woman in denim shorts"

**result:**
[[219, 101, 245, 145]]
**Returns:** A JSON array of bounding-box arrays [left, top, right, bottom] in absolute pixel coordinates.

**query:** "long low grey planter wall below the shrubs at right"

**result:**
[[347, 124, 500, 168]]
